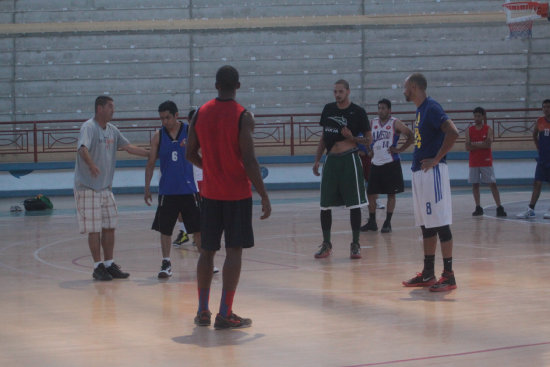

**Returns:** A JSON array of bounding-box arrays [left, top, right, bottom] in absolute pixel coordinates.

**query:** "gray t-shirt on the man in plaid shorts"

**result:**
[[74, 118, 130, 191]]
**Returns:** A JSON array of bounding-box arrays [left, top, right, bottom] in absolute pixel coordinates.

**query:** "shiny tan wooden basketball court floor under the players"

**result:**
[[0, 190, 550, 367]]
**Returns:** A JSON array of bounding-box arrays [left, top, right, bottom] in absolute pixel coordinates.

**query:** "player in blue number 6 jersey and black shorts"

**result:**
[[144, 101, 201, 279]]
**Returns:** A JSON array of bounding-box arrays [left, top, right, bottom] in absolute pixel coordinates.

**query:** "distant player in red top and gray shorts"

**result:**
[[466, 107, 506, 217]]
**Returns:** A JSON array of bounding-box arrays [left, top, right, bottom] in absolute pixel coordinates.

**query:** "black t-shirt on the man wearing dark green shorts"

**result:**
[[319, 102, 370, 152]]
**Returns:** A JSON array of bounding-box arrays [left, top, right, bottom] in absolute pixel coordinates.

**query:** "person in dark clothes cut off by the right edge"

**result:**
[[516, 99, 550, 219]]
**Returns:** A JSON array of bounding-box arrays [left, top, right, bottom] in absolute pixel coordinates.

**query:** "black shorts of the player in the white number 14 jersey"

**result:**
[[367, 161, 405, 195]]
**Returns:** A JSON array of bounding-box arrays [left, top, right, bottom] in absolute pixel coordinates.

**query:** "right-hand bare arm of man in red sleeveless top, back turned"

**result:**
[[239, 111, 271, 219]]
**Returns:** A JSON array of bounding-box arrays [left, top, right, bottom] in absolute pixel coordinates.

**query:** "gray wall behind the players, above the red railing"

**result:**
[[0, 0, 550, 121]]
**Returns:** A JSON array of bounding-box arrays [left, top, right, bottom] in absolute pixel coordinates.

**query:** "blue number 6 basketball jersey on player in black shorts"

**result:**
[[158, 123, 197, 195]]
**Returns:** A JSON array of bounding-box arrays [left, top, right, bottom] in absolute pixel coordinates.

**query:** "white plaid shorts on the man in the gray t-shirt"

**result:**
[[74, 190, 118, 233]]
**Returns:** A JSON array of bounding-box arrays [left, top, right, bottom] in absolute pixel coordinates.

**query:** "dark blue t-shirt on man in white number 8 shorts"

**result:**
[[411, 97, 449, 172]]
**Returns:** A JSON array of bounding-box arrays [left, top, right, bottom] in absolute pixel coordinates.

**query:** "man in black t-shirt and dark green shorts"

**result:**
[[313, 79, 372, 259]]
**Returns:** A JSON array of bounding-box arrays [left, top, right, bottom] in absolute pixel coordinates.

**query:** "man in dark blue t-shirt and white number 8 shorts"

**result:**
[[403, 73, 458, 292]]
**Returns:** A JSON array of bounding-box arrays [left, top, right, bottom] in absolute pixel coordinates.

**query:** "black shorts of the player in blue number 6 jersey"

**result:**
[[151, 194, 201, 236]]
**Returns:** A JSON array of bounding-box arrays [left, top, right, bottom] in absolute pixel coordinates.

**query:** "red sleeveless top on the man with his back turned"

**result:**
[[195, 98, 252, 200]]
